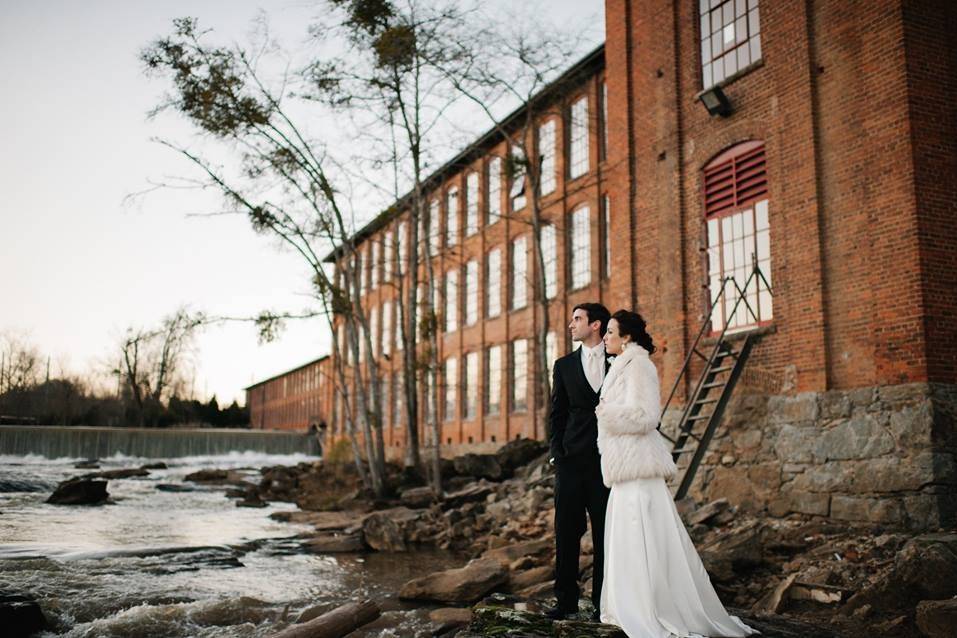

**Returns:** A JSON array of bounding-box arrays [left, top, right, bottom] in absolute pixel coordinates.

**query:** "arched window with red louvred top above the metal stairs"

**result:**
[[704, 142, 773, 331]]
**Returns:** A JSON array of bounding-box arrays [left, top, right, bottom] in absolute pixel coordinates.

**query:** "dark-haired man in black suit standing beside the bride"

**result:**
[[545, 303, 611, 620]]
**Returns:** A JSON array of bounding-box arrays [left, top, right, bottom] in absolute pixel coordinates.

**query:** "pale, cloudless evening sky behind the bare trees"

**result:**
[[0, 0, 604, 405]]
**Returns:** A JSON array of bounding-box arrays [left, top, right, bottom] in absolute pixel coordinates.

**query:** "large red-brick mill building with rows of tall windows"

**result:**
[[250, 0, 957, 528]]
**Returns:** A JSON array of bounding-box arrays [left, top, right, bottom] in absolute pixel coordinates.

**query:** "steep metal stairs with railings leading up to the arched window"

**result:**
[[658, 266, 771, 500]]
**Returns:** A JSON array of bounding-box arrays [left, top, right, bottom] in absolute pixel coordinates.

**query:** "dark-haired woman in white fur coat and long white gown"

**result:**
[[595, 310, 758, 638]]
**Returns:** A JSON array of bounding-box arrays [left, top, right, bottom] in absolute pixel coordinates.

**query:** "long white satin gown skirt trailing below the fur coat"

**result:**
[[601, 478, 758, 638]]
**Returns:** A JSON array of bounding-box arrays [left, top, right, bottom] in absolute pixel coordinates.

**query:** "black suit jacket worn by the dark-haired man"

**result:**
[[548, 347, 610, 461]]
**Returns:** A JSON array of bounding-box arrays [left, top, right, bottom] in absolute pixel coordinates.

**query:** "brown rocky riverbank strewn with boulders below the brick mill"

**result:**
[[86, 440, 957, 638]]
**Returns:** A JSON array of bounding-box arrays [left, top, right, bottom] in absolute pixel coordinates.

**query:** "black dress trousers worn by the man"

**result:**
[[555, 454, 609, 611]]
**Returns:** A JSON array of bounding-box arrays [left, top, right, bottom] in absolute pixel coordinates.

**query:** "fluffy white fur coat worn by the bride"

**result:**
[[595, 343, 677, 487]]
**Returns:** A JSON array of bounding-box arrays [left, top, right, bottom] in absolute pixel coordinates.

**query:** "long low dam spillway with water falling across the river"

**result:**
[[0, 425, 319, 459]]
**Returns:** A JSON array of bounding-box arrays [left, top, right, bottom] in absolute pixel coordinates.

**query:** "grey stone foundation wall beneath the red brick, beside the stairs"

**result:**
[[664, 383, 957, 529]]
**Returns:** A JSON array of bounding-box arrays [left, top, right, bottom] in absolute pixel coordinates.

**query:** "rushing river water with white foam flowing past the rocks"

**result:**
[[0, 453, 464, 638]]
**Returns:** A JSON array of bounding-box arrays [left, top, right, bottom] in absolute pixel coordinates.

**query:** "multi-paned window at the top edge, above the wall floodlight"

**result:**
[[699, 0, 761, 89]]
